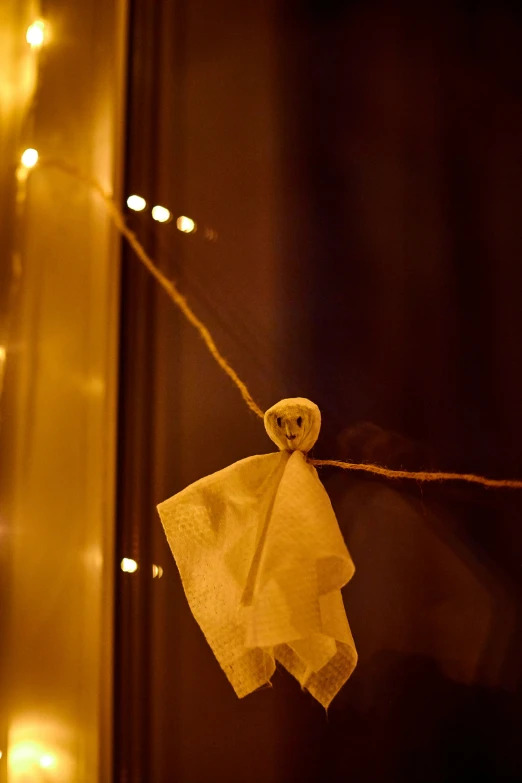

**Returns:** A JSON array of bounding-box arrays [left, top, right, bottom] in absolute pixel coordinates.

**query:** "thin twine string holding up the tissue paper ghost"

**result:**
[[31, 159, 522, 489]]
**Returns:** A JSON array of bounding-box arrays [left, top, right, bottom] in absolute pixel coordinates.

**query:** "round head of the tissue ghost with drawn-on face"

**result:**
[[265, 397, 321, 453]]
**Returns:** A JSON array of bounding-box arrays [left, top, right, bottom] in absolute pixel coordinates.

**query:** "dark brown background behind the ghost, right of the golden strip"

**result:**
[[115, 0, 522, 783]]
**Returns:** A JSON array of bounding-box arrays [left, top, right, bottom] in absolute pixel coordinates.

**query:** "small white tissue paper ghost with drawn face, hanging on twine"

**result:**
[[158, 397, 357, 707]]
